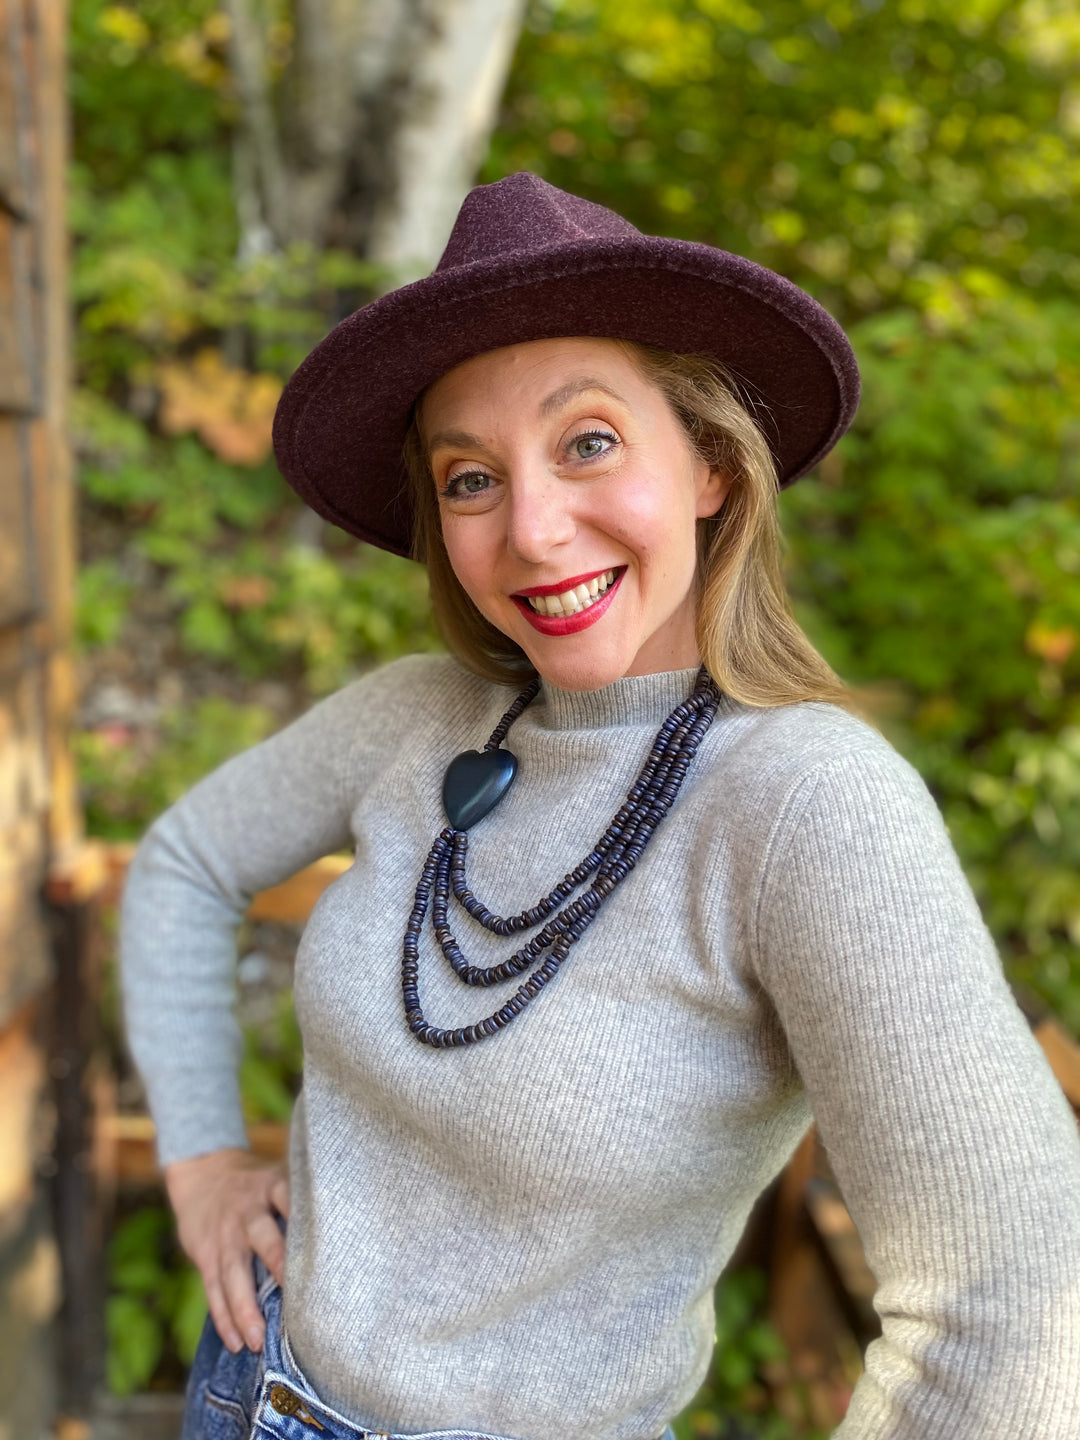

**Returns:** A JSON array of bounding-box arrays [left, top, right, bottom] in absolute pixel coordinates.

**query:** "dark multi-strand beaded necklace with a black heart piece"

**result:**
[[402, 665, 720, 1050]]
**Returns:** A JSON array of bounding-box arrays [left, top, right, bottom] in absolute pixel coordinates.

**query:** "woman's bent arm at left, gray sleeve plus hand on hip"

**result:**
[[121, 657, 445, 1351]]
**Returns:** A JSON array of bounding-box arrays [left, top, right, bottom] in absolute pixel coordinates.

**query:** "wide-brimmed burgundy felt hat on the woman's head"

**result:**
[[274, 171, 858, 554]]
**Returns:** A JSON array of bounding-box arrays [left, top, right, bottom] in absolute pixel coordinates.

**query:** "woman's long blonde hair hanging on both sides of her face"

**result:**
[[405, 340, 854, 708]]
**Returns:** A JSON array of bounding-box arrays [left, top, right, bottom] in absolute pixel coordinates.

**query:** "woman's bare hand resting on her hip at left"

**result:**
[[164, 1149, 289, 1354]]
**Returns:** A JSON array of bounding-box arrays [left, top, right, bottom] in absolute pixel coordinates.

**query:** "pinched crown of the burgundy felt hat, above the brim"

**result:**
[[436, 170, 641, 271]]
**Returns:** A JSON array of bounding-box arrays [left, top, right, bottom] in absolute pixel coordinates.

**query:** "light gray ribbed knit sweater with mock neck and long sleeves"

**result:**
[[122, 657, 1080, 1440]]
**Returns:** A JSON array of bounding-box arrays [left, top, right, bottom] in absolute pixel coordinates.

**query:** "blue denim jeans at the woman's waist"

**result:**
[[180, 1256, 674, 1440]]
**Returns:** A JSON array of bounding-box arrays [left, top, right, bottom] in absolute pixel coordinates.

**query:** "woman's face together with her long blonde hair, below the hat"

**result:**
[[405, 338, 848, 706]]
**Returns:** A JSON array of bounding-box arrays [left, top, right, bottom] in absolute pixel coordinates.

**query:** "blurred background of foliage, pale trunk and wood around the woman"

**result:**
[[0, 0, 1080, 1440]]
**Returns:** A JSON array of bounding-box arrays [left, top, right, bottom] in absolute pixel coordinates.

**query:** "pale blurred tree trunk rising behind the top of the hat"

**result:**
[[226, 0, 524, 284]]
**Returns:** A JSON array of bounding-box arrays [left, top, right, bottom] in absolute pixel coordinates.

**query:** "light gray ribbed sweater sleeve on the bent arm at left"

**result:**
[[121, 681, 379, 1165]]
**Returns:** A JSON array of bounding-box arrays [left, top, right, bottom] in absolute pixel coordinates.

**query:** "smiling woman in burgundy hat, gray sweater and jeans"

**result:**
[[124, 174, 1080, 1440]]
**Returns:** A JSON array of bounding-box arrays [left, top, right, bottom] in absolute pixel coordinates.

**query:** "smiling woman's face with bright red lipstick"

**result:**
[[419, 338, 730, 690]]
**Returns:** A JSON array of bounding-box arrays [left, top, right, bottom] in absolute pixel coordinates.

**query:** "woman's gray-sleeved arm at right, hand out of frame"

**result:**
[[755, 737, 1080, 1440]]
